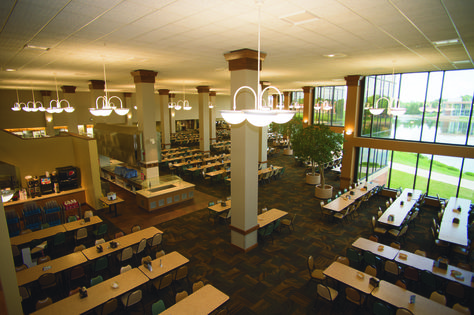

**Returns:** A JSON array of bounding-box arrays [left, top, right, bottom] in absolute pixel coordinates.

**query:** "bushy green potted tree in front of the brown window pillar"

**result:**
[[292, 125, 344, 199]]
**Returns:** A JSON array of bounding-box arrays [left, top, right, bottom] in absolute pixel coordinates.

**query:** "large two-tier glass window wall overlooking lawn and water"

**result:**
[[357, 69, 474, 202]]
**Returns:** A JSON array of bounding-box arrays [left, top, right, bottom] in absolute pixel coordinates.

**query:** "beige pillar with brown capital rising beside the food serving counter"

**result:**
[[131, 70, 160, 179]]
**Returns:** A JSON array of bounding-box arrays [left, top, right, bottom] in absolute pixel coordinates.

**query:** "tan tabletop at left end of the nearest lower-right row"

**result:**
[[324, 261, 374, 294]]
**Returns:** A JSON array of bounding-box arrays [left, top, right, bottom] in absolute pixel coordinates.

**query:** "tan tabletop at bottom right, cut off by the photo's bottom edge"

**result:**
[[371, 280, 459, 315]]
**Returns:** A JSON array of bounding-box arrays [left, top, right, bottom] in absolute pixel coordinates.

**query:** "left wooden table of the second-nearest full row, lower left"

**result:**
[[16, 252, 87, 286]]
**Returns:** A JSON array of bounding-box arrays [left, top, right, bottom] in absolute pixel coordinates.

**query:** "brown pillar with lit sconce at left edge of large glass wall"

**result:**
[[340, 75, 364, 188]]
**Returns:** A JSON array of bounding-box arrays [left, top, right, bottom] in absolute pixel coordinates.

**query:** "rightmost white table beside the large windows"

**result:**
[[438, 197, 471, 246]]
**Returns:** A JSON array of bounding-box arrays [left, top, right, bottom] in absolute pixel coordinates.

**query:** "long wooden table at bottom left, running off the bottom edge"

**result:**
[[32, 268, 148, 315]]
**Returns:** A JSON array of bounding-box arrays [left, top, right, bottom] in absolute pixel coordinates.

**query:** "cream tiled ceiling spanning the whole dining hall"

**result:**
[[0, 0, 474, 94]]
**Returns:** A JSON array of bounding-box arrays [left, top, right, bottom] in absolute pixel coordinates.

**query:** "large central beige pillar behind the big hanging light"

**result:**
[[225, 49, 266, 252]]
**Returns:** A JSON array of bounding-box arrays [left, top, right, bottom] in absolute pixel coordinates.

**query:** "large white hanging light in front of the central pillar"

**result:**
[[221, 0, 295, 127]]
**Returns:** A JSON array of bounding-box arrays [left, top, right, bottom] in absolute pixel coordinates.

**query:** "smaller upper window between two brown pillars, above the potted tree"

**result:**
[[314, 86, 347, 126]]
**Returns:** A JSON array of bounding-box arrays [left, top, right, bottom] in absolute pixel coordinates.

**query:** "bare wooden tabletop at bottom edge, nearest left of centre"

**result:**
[[160, 284, 229, 315]]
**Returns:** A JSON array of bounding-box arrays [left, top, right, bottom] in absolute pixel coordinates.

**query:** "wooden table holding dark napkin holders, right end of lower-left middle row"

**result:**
[[82, 226, 163, 260]]
